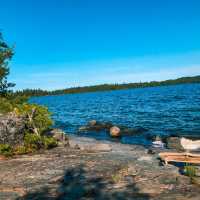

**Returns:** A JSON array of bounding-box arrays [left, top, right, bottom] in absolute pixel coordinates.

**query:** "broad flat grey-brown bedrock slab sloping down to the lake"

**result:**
[[0, 136, 200, 200]]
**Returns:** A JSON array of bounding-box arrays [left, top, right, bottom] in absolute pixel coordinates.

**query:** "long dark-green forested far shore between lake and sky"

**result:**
[[15, 76, 200, 96]]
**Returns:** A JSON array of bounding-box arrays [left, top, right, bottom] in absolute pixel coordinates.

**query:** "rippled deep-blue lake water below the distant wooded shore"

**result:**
[[30, 84, 200, 144]]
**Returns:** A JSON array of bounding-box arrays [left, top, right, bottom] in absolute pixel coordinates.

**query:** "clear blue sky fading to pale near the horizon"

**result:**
[[0, 0, 200, 90]]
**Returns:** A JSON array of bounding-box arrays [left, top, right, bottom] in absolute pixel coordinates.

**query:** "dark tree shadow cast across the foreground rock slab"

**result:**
[[18, 166, 150, 200]]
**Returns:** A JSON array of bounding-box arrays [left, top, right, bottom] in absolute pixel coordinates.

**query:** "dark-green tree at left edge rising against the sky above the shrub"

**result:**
[[0, 33, 15, 97]]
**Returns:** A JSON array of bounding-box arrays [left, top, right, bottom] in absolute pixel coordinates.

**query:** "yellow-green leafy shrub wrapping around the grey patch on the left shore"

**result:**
[[0, 96, 54, 154]]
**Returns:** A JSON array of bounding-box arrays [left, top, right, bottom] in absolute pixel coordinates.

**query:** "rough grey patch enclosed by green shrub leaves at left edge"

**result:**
[[0, 114, 25, 145]]
